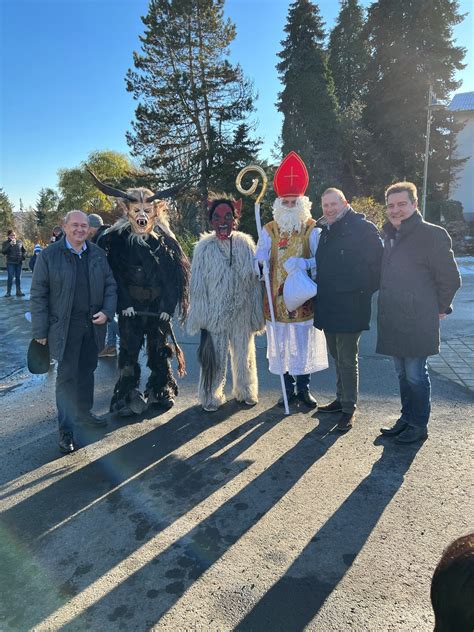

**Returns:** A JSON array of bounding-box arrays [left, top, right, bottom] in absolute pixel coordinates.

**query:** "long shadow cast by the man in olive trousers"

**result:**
[[62, 418, 344, 630]]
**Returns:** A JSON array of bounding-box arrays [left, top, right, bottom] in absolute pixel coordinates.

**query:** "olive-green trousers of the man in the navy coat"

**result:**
[[324, 331, 362, 413]]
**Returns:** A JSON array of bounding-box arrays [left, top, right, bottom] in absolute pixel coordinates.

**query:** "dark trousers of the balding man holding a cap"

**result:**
[[56, 320, 98, 434]]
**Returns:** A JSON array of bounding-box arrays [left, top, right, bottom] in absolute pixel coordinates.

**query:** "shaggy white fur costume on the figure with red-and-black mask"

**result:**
[[187, 231, 265, 409]]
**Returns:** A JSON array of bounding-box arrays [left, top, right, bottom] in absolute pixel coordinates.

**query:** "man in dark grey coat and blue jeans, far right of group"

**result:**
[[377, 182, 461, 443]]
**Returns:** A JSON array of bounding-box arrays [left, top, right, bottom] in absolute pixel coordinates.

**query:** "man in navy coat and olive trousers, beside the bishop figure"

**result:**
[[314, 188, 383, 432]]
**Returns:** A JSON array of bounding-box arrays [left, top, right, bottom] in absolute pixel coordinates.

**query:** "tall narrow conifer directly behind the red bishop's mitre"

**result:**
[[277, 0, 340, 202]]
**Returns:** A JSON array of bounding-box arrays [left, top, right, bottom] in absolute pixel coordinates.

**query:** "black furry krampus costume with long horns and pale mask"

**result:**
[[90, 172, 189, 416]]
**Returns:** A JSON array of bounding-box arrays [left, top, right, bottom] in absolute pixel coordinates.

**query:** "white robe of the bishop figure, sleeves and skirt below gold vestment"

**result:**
[[255, 228, 328, 375]]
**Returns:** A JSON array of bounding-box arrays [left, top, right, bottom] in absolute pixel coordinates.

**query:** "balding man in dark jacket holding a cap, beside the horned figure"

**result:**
[[31, 211, 117, 454]]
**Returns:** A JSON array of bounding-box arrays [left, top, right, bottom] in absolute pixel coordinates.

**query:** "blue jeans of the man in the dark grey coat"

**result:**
[[393, 357, 431, 428]]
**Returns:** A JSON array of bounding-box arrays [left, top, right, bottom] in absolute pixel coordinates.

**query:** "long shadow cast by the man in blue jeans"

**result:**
[[236, 440, 420, 632]]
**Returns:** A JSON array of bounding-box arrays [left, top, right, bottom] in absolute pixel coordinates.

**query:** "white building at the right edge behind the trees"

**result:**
[[448, 92, 474, 222]]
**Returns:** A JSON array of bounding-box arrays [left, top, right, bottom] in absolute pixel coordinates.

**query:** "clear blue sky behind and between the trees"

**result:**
[[0, 0, 474, 210]]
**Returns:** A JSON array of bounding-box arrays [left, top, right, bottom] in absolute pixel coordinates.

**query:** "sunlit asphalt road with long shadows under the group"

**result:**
[[0, 270, 474, 632]]
